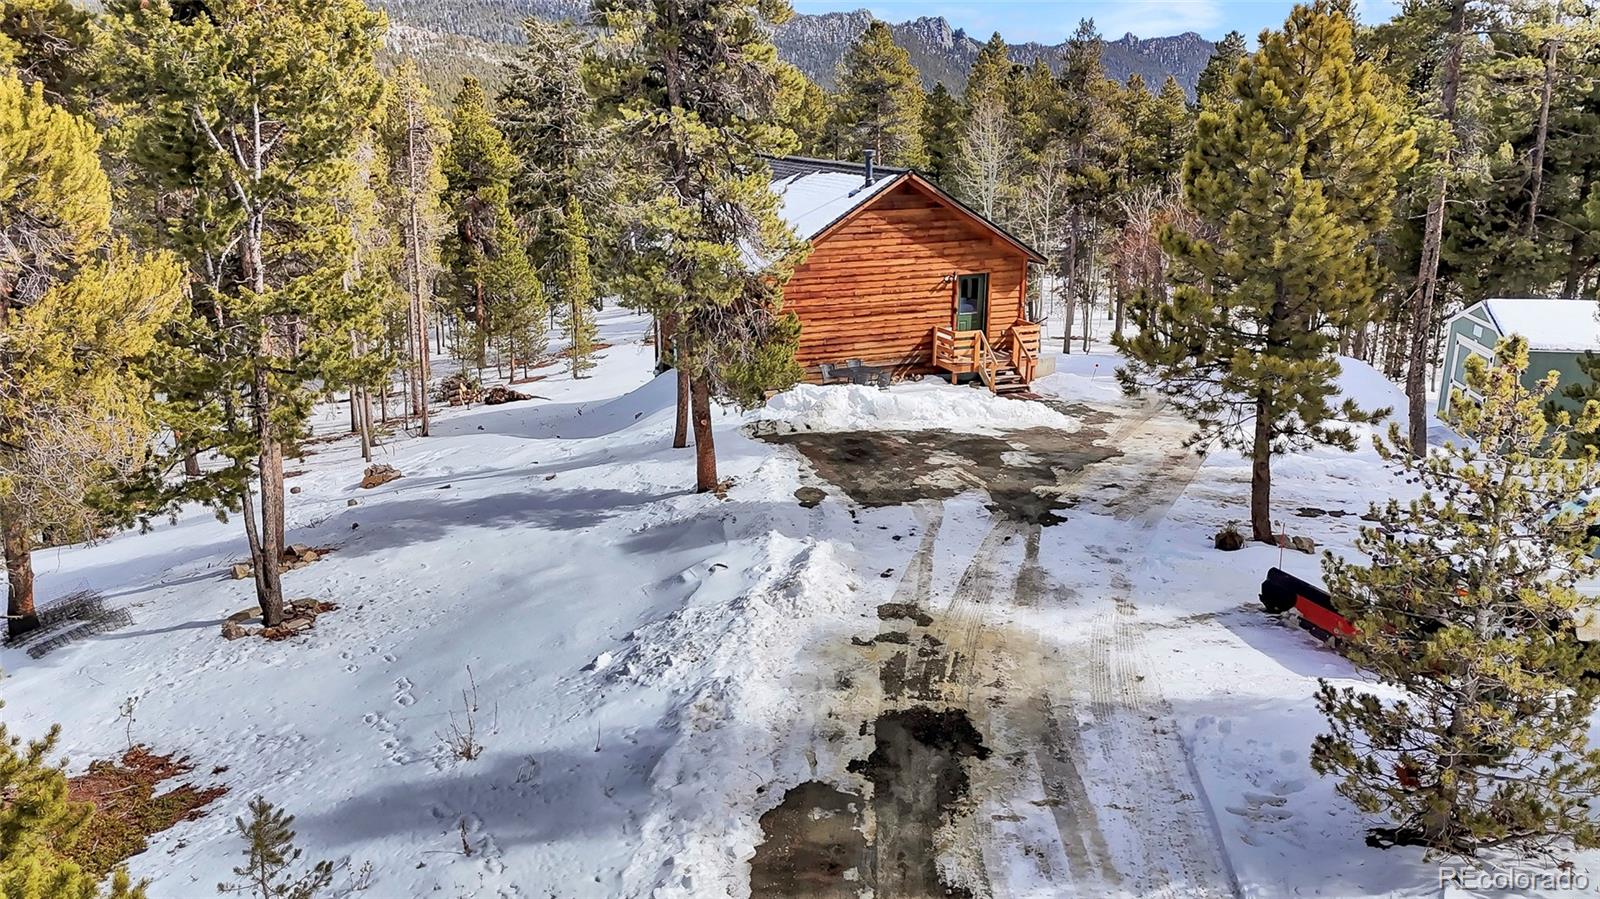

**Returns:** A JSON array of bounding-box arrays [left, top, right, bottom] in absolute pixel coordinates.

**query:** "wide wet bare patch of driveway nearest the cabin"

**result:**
[[762, 413, 1122, 525]]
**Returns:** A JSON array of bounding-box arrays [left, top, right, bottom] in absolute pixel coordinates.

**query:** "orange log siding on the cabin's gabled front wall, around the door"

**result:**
[[784, 181, 1027, 381]]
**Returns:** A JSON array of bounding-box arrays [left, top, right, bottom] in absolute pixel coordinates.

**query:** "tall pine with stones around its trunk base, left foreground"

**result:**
[[109, 0, 384, 627]]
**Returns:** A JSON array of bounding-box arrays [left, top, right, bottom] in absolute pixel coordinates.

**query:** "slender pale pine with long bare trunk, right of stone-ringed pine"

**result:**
[[379, 61, 448, 437]]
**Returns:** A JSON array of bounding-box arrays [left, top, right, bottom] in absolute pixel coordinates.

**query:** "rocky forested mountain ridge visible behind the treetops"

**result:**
[[373, 0, 1214, 98]]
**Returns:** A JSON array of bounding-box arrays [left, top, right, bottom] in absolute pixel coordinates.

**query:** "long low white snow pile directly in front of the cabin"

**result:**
[[755, 379, 1078, 434]]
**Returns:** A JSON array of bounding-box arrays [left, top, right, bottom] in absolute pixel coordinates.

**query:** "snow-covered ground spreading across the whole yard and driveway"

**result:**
[[0, 303, 1600, 899]]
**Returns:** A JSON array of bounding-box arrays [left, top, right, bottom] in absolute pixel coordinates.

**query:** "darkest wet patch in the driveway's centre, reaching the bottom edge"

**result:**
[[850, 705, 989, 896]]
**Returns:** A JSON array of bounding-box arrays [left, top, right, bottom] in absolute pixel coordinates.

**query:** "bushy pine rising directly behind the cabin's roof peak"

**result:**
[[837, 21, 928, 168]]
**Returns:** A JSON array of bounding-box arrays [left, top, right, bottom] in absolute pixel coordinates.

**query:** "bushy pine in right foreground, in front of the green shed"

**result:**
[[1312, 338, 1600, 856]]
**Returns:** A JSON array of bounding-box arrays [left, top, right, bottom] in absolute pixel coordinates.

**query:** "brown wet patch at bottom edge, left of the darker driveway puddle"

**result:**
[[750, 781, 872, 899]]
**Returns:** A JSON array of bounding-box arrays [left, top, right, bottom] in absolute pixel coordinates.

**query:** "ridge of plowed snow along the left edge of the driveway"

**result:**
[[608, 531, 864, 899]]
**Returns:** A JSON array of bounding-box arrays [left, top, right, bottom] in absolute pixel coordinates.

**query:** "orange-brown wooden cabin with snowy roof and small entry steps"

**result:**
[[770, 154, 1045, 394]]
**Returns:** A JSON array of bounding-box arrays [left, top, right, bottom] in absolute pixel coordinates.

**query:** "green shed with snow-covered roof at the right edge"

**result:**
[[1438, 298, 1600, 413]]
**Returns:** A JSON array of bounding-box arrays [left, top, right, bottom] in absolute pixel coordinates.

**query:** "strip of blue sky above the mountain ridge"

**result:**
[[790, 0, 1398, 43]]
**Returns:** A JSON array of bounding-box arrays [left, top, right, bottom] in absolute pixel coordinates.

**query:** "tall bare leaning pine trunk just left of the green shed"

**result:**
[[1405, 0, 1467, 457]]
